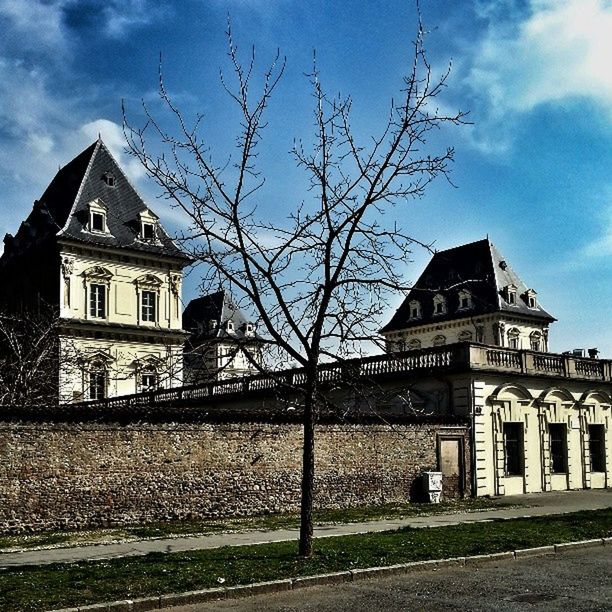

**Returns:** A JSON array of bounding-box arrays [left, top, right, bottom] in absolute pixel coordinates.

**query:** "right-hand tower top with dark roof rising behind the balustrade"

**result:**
[[381, 238, 555, 350]]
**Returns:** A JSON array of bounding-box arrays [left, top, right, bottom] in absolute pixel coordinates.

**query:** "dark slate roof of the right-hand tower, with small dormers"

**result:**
[[381, 238, 555, 332]]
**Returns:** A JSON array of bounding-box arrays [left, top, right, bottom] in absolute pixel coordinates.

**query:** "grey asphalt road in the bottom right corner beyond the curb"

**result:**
[[166, 546, 612, 612]]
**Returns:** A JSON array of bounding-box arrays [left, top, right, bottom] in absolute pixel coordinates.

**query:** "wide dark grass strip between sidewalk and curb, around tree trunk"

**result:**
[[0, 509, 612, 612]]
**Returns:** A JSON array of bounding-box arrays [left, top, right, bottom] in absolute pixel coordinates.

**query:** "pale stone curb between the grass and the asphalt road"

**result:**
[[51, 537, 612, 612]]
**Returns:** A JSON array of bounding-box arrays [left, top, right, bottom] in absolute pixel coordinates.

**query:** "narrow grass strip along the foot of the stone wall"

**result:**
[[0, 499, 510, 549]]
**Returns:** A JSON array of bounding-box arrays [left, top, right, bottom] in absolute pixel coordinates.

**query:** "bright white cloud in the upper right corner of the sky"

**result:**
[[465, 0, 612, 150]]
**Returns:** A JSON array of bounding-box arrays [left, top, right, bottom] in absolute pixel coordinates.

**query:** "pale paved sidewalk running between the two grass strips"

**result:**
[[0, 489, 612, 568]]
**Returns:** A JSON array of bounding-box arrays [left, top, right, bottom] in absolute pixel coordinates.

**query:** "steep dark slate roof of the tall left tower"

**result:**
[[5, 139, 189, 260]]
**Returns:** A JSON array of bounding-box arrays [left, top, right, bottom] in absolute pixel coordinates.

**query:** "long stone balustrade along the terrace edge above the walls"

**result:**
[[73, 342, 612, 409]]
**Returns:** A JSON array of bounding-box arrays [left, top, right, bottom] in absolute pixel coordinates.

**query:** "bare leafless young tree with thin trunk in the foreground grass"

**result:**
[[124, 19, 465, 556]]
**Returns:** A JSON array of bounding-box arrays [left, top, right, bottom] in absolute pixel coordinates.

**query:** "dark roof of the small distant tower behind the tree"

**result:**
[[183, 289, 261, 342]]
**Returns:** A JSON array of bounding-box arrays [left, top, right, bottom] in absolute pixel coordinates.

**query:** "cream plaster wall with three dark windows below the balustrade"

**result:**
[[473, 376, 612, 496]]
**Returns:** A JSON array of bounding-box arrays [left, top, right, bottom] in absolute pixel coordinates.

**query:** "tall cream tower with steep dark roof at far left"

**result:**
[[0, 140, 189, 402]]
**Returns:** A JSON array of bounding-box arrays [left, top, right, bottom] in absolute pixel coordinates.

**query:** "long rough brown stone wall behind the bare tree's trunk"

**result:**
[[0, 421, 470, 532]]
